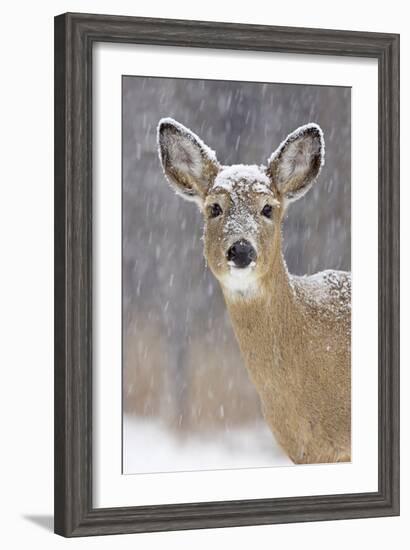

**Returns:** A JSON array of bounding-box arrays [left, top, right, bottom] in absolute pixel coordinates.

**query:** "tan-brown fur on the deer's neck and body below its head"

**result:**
[[222, 216, 350, 463]]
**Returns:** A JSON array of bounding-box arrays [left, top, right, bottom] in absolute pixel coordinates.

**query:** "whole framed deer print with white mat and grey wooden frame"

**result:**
[[55, 14, 399, 536]]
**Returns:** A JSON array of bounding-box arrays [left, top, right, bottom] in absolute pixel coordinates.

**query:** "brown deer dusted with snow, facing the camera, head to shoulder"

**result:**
[[158, 118, 351, 463]]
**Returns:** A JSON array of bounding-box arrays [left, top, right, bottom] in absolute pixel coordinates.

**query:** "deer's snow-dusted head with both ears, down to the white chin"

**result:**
[[158, 118, 324, 295]]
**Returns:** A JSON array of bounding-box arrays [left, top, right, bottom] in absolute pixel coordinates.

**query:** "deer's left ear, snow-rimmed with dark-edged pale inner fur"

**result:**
[[158, 118, 219, 205]]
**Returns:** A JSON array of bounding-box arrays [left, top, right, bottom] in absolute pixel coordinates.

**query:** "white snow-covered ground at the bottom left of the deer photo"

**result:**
[[123, 415, 292, 474]]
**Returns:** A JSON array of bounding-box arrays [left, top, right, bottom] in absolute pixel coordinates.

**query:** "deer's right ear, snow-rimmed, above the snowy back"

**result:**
[[268, 123, 325, 201]]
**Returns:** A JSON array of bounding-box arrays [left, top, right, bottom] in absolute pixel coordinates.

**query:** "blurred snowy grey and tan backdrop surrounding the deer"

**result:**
[[122, 76, 351, 473]]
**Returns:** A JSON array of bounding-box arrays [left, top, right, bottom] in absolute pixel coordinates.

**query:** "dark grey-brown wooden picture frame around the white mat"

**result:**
[[55, 14, 399, 537]]
